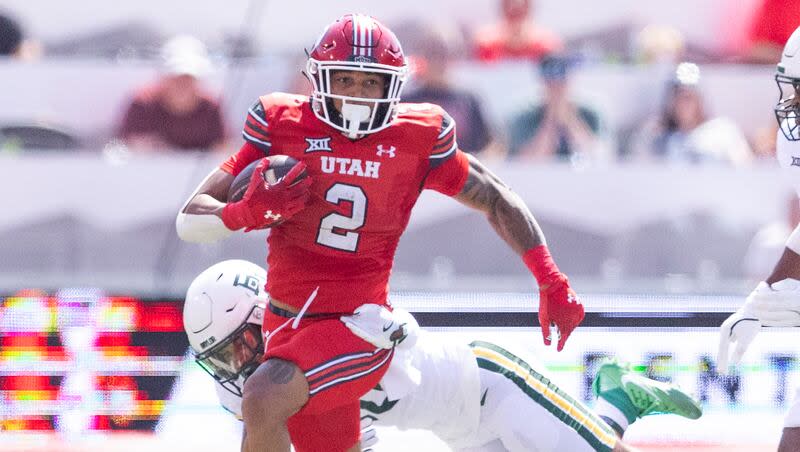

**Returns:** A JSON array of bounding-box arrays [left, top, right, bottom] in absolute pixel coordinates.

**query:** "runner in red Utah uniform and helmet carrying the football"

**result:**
[[176, 14, 584, 451]]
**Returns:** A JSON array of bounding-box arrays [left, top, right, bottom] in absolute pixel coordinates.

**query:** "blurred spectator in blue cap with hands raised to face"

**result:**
[[509, 55, 607, 161]]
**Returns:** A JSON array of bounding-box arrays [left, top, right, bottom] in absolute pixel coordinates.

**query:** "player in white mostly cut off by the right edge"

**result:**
[[717, 23, 800, 452]]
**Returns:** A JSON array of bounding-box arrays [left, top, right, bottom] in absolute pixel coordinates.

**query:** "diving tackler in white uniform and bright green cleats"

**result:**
[[191, 260, 701, 452]]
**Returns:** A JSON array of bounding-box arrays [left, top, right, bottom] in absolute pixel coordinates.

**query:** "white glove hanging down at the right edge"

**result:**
[[717, 279, 800, 373]]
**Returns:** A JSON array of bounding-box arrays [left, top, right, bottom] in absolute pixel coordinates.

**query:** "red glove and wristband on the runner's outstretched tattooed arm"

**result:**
[[522, 245, 584, 351]]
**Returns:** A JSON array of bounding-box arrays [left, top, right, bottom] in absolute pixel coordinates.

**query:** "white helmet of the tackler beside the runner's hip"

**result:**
[[183, 260, 267, 396]]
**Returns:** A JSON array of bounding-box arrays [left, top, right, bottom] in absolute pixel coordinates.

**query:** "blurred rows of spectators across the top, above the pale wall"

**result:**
[[0, 0, 800, 162]]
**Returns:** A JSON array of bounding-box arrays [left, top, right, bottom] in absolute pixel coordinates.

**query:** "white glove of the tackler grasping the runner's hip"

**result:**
[[340, 303, 410, 349]]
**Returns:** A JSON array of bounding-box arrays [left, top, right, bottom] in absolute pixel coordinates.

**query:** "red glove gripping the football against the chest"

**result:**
[[221, 159, 311, 232]]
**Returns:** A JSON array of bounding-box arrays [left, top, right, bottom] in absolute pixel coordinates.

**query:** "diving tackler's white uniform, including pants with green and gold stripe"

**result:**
[[217, 331, 617, 452]]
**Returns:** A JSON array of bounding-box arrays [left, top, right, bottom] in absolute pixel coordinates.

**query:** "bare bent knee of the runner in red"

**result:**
[[242, 359, 308, 420]]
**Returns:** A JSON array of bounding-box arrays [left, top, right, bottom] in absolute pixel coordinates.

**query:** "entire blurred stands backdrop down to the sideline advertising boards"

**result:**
[[0, 0, 800, 292]]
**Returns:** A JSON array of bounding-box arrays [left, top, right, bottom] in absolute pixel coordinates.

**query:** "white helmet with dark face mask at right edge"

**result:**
[[775, 27, 800, 141]]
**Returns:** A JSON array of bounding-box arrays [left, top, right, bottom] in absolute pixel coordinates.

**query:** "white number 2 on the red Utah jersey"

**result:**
[[317, 183, 367, 252]]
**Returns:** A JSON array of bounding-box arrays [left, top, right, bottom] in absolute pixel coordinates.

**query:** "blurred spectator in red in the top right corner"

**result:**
[[743, 0, 800, 64]]
